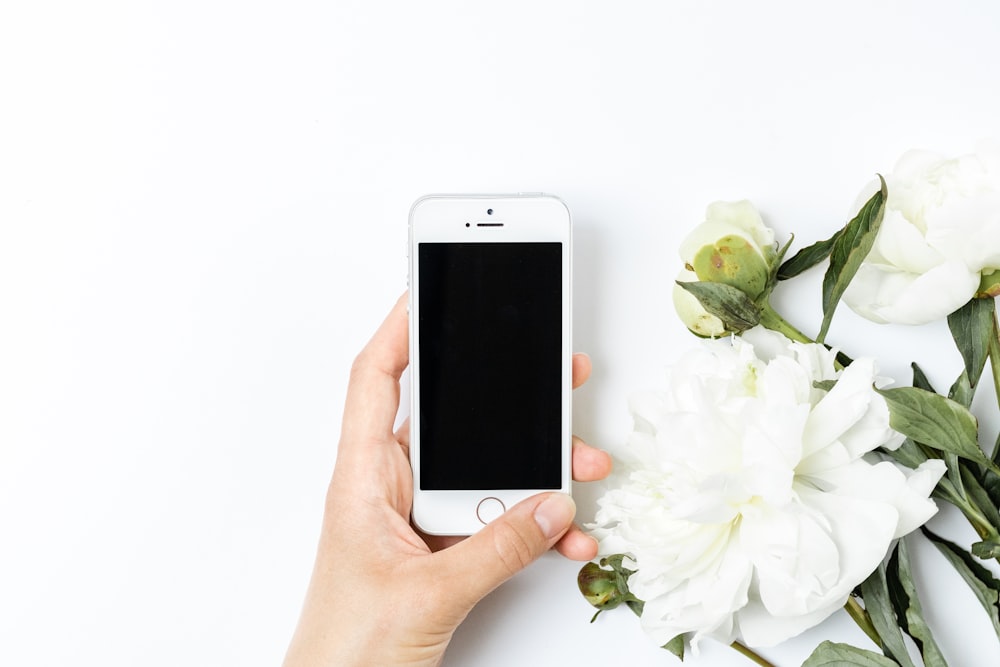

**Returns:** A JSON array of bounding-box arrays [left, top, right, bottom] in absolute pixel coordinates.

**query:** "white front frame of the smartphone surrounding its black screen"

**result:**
[[408, 194, 572, 535]]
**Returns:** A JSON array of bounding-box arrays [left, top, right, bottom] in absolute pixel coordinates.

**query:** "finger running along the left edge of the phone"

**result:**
[[341, 294, 410, 446]]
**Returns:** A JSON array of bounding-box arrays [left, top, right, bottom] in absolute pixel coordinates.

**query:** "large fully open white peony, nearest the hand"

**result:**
[[589, 327, 945, 646]]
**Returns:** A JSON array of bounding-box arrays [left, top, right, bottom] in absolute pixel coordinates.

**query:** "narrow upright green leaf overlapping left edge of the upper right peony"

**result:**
[[816, 175, 888, 343]]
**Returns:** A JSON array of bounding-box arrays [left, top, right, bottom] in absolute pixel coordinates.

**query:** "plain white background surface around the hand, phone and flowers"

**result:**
[[0, 0, 1000, 666]]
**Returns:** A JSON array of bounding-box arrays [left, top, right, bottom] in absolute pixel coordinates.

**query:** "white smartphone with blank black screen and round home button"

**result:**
[[409, 194, 572, 535]]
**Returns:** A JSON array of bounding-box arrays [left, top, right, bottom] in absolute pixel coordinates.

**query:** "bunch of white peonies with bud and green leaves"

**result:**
[[578, 144, 1000, 667]]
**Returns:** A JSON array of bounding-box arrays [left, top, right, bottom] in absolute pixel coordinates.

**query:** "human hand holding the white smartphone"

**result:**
[[285, 295, 611, 667]]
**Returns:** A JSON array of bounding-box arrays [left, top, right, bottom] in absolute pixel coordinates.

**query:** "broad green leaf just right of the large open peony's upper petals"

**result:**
[[876, 387, 988, 463]]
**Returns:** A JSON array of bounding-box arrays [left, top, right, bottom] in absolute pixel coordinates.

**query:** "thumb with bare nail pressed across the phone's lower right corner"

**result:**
[[438, 493, 576, 609]]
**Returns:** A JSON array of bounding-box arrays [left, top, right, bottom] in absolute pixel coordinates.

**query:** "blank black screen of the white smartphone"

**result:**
[[417, 242, 563, 491]]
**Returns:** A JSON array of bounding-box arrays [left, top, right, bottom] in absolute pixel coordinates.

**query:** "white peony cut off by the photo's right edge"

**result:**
[[844, 143, 1000, 324]]
